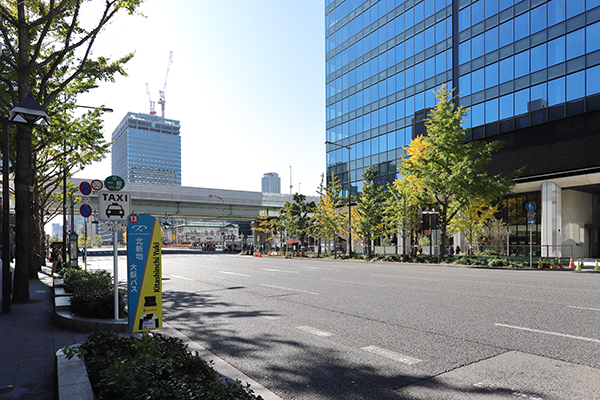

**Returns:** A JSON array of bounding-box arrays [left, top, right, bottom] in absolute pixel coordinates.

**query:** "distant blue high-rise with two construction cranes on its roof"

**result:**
[[112, 112, 181, 186]]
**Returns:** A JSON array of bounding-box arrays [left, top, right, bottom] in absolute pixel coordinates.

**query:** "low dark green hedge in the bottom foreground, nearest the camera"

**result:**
[[65, 331, 262, 400]]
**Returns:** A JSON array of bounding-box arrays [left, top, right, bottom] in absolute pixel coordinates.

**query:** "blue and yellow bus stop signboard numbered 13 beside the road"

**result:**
[[127, 214, 162, 332]]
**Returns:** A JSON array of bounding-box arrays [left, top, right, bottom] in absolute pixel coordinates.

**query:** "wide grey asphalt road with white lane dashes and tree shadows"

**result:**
[[89, 254, 600, 400]]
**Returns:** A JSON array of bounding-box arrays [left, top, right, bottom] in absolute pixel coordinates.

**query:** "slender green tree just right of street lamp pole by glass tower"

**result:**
[[356, 167, 386, 259]]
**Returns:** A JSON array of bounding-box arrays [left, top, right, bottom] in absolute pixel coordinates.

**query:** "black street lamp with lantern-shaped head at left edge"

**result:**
[[0, 92, 50, 313]]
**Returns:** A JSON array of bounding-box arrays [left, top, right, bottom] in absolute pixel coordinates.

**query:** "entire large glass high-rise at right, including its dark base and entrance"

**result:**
[[325, 0, 600, 257]]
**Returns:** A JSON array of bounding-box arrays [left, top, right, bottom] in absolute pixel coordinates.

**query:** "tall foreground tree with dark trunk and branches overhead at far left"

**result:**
[[0, 0, 143, 303]]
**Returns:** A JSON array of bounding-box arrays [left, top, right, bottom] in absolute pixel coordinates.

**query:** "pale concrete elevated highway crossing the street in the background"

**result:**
[[70, 178, 318, 221]]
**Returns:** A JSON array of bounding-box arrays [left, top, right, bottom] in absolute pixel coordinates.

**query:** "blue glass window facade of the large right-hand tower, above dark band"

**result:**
[[326, 0, 600, 192]]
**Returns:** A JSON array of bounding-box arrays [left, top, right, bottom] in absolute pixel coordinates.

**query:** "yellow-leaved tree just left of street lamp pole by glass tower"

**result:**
[[311, 174, 348, 254]]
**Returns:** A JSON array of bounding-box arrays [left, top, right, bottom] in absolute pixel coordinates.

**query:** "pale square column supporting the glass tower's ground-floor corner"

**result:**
[[541, 182, 562, 257]]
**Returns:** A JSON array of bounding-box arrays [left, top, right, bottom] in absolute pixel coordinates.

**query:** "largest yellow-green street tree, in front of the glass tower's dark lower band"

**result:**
[[402, 85, 514, 259]]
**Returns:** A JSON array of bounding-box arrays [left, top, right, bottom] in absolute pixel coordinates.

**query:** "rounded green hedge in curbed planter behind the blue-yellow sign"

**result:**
[[60, 268, 126, 319]]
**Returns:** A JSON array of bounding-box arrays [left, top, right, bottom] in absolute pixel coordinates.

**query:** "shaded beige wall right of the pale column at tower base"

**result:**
[[561, 189, 593, 258]]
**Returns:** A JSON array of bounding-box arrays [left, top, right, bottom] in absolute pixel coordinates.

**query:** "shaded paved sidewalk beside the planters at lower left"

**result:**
[[0, 267, 87, 400]]
